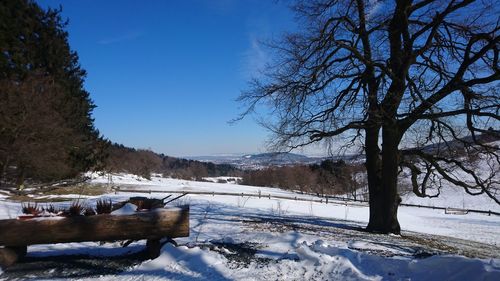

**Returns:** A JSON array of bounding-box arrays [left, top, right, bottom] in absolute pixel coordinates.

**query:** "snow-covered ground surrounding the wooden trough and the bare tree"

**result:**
[[0, 172, 500, 280]]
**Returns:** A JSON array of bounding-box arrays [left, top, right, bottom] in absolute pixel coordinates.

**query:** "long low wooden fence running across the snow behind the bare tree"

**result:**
[[113, 187, 500, 216]]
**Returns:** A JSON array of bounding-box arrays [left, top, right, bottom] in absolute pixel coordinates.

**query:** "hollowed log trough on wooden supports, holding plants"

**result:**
[[0, 206, 189, 267]]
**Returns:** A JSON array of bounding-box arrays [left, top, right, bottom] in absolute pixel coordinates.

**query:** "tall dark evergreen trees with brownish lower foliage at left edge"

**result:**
[[0, 0, 101, 184]]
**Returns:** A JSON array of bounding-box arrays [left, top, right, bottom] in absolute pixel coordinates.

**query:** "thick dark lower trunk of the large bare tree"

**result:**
[[367, 125, 401, 234]]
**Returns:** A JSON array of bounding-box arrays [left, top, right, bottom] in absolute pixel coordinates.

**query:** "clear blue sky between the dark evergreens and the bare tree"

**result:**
[[37, 0, 293, 156]]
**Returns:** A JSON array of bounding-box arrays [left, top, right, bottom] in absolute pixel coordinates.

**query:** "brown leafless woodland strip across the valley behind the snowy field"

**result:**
[[102, 142, 367, 199]]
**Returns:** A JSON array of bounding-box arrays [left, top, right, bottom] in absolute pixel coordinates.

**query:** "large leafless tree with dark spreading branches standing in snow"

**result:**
[[240, 0, 500, 233]]
